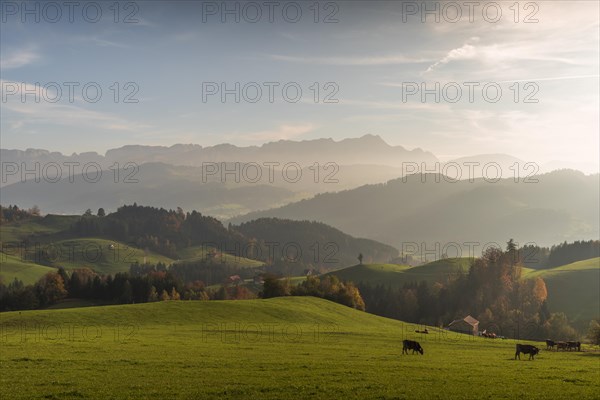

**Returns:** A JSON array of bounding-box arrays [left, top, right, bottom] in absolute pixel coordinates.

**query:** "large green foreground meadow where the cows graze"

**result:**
[[0, 297, 600, 400]]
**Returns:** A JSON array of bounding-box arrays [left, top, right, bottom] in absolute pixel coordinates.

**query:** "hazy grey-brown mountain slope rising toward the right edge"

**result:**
[[232, 170, 600, 250]]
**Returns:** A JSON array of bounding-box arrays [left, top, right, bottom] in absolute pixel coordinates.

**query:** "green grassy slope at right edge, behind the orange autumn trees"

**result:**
[[525, 257, 600, 321]]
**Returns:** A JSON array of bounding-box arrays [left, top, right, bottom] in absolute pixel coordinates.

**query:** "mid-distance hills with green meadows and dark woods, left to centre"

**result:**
[[0, 204, 398, 281]]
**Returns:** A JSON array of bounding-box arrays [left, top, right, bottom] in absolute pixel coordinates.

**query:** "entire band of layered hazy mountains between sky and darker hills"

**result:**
[[0, 135, 598, 238]]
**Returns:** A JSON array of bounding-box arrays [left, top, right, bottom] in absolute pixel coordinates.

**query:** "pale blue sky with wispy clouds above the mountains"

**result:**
[[0, 1, 600, 172]]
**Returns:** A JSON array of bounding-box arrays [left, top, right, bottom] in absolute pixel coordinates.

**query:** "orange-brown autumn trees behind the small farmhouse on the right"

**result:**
[[358, 242, 577, 339]]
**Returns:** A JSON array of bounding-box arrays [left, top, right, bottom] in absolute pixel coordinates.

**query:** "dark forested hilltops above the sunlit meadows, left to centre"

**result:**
[[1, 204, 398, 271]]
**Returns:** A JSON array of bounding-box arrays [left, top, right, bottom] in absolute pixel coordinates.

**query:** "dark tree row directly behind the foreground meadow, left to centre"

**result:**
[[0, 264, 365, 311]]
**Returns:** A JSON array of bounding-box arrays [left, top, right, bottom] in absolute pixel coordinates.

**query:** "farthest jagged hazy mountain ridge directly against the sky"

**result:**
[[0, 135, 438, 184]]
